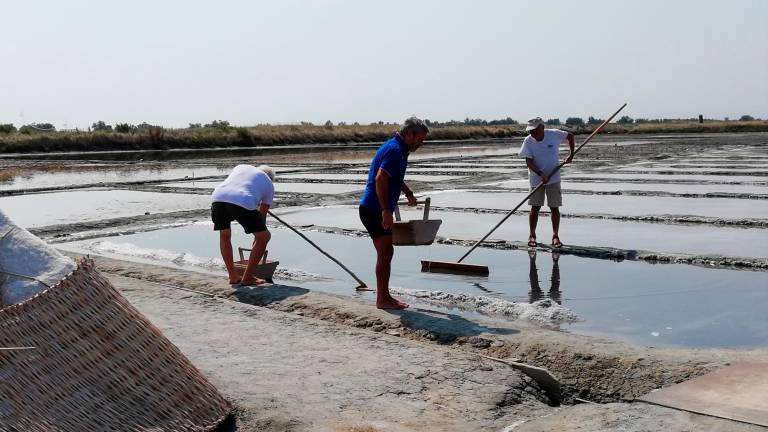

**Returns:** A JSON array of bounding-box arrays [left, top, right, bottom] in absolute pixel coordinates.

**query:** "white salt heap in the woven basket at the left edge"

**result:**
[[0, 210, 76, 305]]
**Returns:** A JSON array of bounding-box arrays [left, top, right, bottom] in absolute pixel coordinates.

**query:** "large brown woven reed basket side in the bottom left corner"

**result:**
[[0, 259, 231, 432]]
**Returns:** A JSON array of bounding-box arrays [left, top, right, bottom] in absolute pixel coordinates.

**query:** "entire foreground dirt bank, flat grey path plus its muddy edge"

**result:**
[[91, 258, 768, 432]]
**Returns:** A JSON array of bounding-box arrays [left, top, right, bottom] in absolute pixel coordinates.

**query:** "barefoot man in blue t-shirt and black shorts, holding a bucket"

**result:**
[[360, 117, 429, 309]]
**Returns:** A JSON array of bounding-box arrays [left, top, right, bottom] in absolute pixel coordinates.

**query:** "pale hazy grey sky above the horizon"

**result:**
[[0, 0, 768, 129]]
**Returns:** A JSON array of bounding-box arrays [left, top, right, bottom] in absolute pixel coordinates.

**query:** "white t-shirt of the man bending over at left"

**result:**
[[211, 165, 275, 210]]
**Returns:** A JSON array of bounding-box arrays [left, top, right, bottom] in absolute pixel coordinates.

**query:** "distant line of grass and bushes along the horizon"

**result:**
[[0, 116, 768, 153]]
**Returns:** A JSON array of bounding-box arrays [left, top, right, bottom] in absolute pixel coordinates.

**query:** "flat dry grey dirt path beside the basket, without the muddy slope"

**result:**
[[110, 275, 551, 431]]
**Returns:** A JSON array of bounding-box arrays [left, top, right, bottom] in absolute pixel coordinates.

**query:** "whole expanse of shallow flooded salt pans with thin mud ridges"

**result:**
[[0, 134, 768, 347]]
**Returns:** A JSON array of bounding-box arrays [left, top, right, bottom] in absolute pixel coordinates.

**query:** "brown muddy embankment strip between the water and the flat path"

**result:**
[[66, 251, 766, 404]]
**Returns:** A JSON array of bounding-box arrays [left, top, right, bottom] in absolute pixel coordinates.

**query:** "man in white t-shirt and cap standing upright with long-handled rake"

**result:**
[[518, 117, 574, 248]]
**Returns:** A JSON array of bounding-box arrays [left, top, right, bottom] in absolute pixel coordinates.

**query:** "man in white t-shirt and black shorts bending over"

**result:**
[[211, 165, 275, 285]]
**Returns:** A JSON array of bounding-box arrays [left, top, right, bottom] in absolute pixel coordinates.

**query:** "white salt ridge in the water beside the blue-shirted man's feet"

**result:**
[[390, 287, 582, 324]]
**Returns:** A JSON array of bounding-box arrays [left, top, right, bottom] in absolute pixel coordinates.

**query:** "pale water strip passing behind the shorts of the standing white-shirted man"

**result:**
[[432, 191, 768, 219]]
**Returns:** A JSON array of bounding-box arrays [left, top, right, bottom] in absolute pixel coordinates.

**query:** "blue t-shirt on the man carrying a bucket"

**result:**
[[360, 133, 408, 212]]
